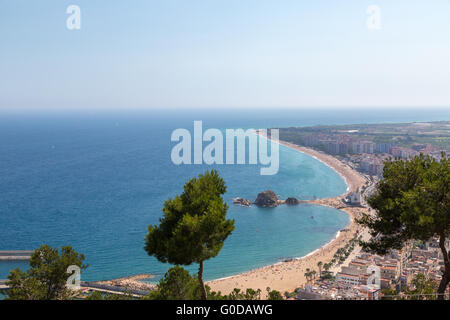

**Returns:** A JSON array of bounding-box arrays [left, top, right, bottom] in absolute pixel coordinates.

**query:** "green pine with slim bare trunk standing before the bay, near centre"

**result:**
[[145, 170, 234, 299]]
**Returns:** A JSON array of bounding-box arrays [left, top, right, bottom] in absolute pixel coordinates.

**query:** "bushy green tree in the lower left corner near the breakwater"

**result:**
[[6, 245, 87, 300]]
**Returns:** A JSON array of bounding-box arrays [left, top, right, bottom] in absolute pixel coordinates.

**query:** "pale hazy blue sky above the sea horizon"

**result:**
[[0, 0, 450, 111]]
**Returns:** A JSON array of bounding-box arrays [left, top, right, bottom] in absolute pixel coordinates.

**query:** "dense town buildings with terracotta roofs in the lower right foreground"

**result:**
[[296, 239, 450, 300]]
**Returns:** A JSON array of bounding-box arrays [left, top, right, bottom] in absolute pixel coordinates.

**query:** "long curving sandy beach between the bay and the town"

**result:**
[[207, 135, 367, 294]]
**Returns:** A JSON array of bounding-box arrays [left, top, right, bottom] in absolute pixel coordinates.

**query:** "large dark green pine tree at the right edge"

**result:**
[[357, 154, 450, 299]]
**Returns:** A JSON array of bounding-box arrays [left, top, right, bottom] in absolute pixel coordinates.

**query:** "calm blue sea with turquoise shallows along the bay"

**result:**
[[0, 109, 450, 281]]
